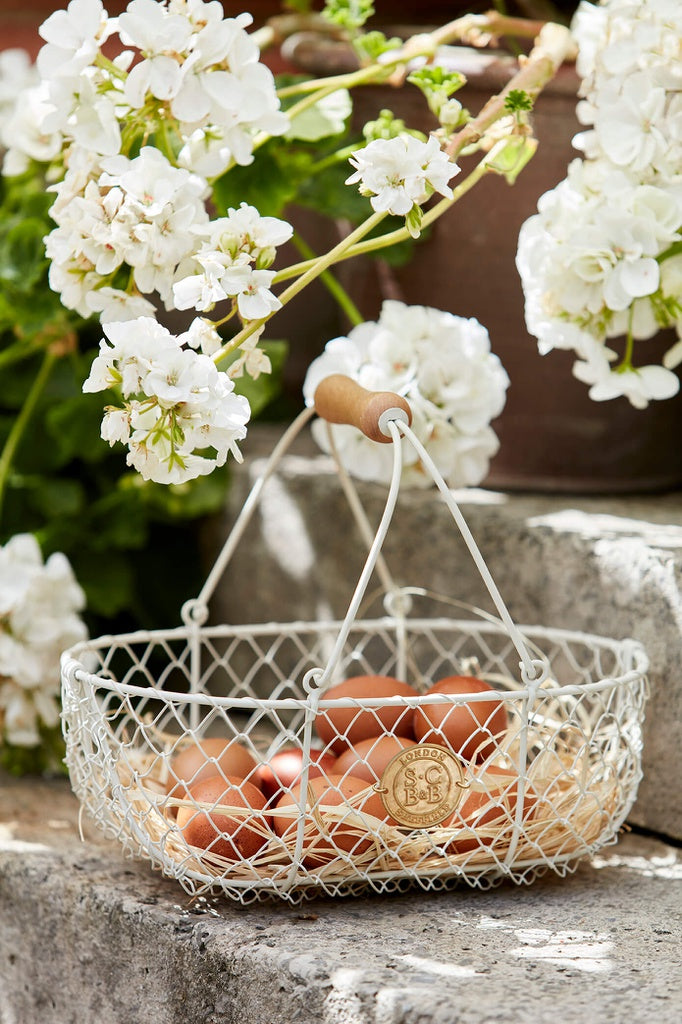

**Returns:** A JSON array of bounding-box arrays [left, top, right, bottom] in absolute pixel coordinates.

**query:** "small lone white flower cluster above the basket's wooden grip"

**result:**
[[346, 135, 459, 224]]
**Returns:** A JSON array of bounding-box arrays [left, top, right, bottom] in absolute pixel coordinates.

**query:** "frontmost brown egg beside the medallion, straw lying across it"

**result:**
[[272, 775, 391, 867]]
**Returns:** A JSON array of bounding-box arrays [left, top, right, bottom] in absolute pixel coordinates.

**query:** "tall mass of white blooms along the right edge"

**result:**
[[517, 0, 682, 408]]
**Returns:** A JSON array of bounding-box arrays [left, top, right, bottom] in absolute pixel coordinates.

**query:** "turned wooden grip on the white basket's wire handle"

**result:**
[[315, 374, 412, 443]]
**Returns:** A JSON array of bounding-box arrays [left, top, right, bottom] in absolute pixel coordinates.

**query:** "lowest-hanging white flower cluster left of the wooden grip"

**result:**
[[83, 316, 250, 483]]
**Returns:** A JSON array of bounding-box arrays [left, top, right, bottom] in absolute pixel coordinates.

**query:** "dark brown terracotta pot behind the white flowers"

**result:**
[[286, 41, 682, 493]]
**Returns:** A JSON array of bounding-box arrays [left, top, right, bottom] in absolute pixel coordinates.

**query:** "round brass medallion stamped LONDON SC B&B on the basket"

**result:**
[[376, 743, 468, 828]]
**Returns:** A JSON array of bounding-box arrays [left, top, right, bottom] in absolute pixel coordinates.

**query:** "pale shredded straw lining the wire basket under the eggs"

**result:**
[[89, 712, 623, 889]]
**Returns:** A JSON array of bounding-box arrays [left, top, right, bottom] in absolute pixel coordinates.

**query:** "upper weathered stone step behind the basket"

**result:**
[[205, 428, 682, 838]]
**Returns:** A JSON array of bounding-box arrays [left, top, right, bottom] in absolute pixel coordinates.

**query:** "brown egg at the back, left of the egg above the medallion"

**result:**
[[315, 676, 419, 754]]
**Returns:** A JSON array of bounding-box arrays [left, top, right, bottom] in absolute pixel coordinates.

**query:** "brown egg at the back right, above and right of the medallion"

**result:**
[[413, 676, 509, 762]]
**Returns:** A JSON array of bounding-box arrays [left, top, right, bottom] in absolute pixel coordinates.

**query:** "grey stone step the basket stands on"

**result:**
[[0, 778, 682, 1024]]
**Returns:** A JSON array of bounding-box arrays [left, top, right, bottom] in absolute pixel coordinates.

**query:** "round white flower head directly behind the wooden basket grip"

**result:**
[[303, 300, 509, 487]]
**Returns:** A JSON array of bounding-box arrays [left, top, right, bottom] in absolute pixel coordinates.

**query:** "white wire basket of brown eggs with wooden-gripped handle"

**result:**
[[61, 381, 648, 903]]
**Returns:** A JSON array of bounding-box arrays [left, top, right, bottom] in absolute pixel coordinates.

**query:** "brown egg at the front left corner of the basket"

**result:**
[[177, 775, 270, 860]]
